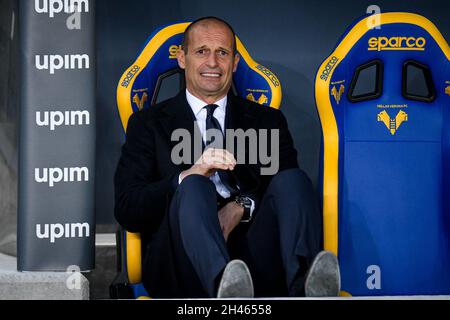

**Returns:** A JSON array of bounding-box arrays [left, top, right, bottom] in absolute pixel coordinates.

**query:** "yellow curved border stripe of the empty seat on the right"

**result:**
[[315, 12, 450, 255]]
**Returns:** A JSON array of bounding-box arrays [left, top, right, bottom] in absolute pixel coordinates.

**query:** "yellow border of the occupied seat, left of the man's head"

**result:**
[[117, 22, 190, 131]]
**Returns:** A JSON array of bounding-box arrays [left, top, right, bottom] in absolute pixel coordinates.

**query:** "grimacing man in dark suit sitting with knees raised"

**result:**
[[115, 17, 340, 298]]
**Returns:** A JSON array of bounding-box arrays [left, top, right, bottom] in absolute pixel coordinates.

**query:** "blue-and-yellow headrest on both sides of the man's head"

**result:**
[[117, 22, 282, 129]]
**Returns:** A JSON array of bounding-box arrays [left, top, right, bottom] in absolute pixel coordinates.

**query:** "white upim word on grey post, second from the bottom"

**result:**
[[34, 167, 89, 187]]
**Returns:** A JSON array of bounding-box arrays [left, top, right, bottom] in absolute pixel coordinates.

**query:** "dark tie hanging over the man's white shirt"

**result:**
[[205, 104, 239, 195]]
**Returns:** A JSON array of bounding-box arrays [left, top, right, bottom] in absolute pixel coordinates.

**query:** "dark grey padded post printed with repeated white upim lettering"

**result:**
[[17, 0, 95, 271]]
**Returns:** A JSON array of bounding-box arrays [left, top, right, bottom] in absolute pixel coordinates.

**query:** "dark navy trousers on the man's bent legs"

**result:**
[[143, 169, 322, 297]]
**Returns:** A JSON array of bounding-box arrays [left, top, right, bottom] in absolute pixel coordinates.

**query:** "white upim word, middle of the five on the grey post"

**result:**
[[36, 110, 90, 131]]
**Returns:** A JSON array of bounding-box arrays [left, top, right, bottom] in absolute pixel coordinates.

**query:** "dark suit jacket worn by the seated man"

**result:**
[[114, 91, 298, 235]]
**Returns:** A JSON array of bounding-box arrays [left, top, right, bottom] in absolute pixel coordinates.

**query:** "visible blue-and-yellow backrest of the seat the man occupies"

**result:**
[[112, 22, 282, 296]]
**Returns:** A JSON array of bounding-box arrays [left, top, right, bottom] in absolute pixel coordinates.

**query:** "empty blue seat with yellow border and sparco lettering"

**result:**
[[315, 12, 450, 295]]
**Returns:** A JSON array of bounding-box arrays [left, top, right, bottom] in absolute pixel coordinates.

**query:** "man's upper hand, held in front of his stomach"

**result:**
[[180, 148, 236, 182]]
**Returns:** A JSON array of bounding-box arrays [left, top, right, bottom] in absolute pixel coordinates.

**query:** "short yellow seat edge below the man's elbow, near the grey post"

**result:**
[[126, 231, 142, 284]]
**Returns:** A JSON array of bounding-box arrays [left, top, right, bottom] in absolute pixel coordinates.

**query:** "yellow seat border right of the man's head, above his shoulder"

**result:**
[[236, 37, 282, 109]]
